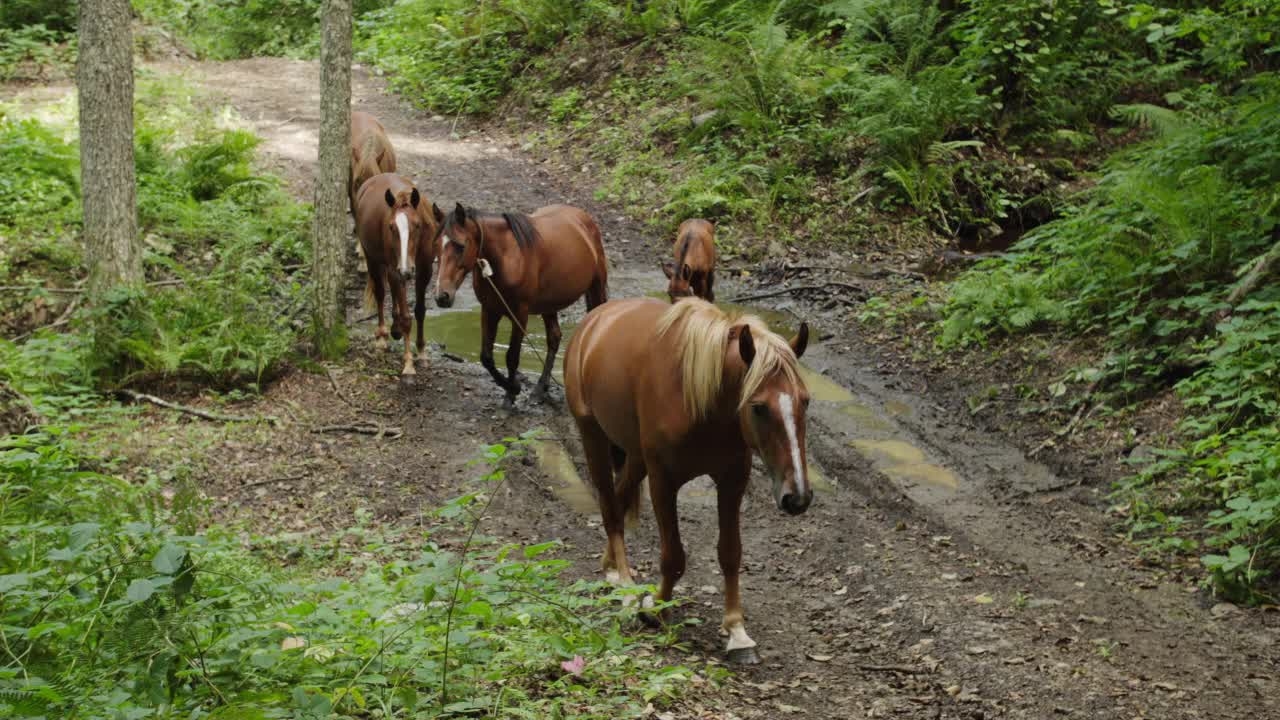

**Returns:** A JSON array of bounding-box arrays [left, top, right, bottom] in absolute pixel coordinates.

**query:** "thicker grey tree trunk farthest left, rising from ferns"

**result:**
[[76, 0, 142, 304]]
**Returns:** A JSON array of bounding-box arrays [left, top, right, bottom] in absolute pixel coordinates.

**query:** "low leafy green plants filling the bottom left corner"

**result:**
[[0, 428, 694, 720]]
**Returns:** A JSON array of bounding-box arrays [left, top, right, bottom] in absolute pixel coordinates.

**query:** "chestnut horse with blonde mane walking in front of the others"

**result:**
[[564, 299, 813, 662]]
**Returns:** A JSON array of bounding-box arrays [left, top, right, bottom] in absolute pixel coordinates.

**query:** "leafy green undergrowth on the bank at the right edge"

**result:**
[[941, 74, 1280, 598]]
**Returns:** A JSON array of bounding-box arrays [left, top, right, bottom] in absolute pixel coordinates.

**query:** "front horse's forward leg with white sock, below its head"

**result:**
[[714, 456, 760, 665]]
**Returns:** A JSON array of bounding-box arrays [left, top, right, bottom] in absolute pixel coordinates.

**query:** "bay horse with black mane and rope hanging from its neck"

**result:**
[[435, 204, 609, 407]]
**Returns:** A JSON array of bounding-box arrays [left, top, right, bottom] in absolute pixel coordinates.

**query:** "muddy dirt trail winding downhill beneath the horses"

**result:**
[[165, 59, 1280, 719]]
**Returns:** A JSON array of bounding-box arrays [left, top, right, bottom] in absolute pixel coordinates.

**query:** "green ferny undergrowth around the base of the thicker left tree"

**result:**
[[0, 71, 308, 388]]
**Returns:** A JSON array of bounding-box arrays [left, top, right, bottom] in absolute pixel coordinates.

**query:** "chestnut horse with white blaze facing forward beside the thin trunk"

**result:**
[[356, 173, 442, 375]]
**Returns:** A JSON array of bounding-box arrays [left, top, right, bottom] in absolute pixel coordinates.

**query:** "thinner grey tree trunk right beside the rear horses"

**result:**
[[311, 0, 351, 357]]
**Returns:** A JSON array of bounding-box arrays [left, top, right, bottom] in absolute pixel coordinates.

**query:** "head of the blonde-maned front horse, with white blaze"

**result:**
[[728, 323, 813, 515]]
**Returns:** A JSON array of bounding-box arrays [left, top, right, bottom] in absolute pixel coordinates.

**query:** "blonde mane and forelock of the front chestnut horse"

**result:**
[[658, 297, 801, 420]]
